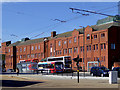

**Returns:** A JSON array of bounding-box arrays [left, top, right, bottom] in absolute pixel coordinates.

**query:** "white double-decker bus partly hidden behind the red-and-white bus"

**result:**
[[47, 56, 72, 72]]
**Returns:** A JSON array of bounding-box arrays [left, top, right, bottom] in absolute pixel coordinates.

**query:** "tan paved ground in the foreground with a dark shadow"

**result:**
[[2, 74, 120, 88]]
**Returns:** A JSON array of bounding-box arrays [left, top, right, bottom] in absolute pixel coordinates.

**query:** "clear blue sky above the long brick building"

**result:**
[[2, 2, 118, 42]]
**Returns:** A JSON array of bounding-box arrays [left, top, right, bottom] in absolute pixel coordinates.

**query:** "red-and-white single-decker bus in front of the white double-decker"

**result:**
[[38, 62, 64, 73]]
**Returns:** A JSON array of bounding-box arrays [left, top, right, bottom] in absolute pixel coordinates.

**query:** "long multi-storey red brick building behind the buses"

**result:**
[[3, 17, 120, 71]]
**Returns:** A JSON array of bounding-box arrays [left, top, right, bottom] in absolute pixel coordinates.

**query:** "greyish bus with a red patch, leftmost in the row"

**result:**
[[17, 62, 38, 73]]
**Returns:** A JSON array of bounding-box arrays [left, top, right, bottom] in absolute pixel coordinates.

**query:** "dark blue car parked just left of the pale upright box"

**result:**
[[90, 66, 109, 77]]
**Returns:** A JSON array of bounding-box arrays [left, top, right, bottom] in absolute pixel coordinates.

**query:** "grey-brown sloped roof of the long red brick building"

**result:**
[[9, 22, 120, 46]]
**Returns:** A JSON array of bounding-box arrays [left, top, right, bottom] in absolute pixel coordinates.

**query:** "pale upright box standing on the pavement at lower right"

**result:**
[[109, 71, 118, 84]]
